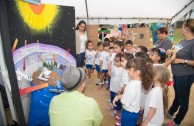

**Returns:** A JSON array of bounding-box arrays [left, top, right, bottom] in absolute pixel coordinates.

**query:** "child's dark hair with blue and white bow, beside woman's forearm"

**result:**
[[151, 48, 166, 63]]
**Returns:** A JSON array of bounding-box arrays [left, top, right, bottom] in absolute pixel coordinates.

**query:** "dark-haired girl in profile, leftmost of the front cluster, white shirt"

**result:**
[[110, 53, 124, 115]]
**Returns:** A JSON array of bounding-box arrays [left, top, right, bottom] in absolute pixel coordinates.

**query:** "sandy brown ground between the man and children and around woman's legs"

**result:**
[[85, 72, 194, 126]]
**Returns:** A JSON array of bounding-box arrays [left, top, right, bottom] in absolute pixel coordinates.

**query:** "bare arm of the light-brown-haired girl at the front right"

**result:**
[[142, 107, 157, 126]]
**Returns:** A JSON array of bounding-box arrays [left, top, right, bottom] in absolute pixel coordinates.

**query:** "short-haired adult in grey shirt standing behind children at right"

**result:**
[[154, 27, 173, 51]]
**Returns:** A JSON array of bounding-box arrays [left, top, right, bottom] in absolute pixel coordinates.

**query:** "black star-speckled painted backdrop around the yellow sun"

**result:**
[[6, 0, 76, 57]]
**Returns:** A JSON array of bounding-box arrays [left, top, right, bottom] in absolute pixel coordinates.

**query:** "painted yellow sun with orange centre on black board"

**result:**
[[16, 0, 59, 33]]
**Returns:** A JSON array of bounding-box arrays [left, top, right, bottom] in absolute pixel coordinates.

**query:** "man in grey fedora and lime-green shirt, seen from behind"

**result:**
[[49, 65, 103, 126]]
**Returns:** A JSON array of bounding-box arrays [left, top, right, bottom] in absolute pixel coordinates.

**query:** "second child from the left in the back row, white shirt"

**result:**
[[95, 42, 103, 85]]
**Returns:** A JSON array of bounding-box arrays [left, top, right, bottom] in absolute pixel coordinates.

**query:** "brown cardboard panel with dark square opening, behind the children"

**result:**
[[125, 28, 153, 48]]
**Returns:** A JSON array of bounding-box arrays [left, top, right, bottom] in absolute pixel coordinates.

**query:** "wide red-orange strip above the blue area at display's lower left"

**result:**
[[19, 83, 48, 96]]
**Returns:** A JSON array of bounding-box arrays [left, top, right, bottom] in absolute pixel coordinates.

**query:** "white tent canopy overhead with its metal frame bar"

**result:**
[[41, 0, 194, 24]]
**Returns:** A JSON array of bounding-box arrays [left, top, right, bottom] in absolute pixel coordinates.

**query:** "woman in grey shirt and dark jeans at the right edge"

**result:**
[[168, 19, 194, 126]]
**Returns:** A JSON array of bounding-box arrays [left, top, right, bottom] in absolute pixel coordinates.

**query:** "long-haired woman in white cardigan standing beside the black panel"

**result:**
[[75, 20, 88, 67]]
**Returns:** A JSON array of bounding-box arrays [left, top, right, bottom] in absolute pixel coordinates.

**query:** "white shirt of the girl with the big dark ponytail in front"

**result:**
[[121, 80, 142, 113]]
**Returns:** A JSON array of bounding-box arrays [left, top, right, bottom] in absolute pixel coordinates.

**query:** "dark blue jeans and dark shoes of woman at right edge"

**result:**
[[168, 75, 194, 124]]
